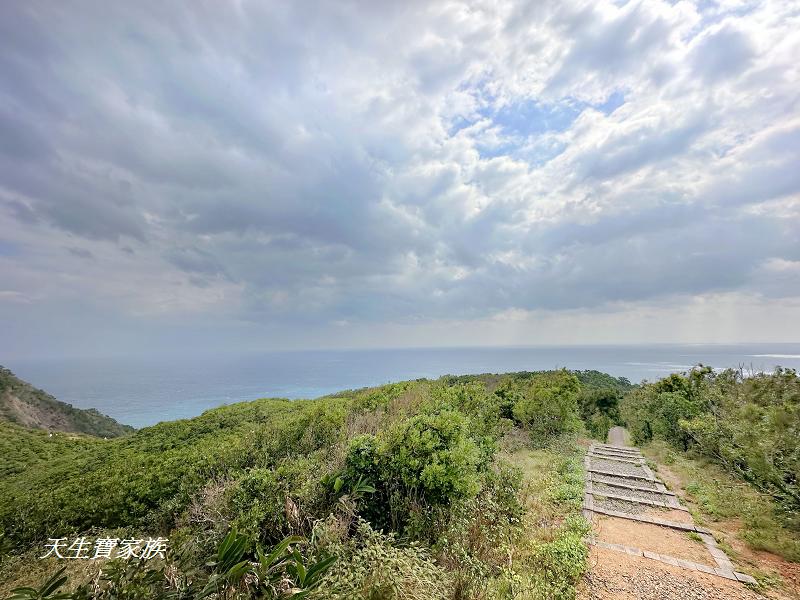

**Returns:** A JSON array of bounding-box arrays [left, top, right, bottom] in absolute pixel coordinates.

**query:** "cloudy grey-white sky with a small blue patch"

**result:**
[[0, 0, 800, 357]]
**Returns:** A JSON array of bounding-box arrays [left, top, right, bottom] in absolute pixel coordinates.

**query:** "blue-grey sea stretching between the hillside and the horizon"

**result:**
[[5, 344, 800, 427]]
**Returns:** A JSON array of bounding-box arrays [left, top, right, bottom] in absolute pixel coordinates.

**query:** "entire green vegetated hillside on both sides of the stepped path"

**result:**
[[0, 370, 800, 600]]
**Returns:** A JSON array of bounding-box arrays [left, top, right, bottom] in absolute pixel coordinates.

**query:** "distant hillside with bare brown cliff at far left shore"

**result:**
[[0, 367, 133, 437]]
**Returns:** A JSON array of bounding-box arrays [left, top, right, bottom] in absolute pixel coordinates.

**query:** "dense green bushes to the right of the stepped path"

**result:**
[[621, 366, 800, 560]]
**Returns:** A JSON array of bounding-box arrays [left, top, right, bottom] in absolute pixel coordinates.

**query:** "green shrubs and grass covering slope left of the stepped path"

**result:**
[[0, 371, 604, 598]]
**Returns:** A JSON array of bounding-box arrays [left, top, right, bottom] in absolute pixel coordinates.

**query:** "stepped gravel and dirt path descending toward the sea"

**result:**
[[580, 427, 760, 600]]
